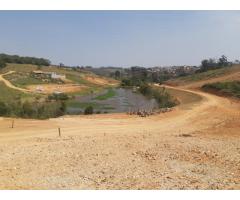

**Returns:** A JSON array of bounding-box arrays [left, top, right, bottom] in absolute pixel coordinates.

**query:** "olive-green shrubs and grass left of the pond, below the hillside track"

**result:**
[[0, 82, 66, 119]]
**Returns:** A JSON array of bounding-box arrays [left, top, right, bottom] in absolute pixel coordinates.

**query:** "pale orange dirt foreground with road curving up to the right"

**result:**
[[0, 88, 240, 189]]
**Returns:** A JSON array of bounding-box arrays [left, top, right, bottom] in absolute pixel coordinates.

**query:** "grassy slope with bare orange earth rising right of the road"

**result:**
[[165, 65, 240, 88]]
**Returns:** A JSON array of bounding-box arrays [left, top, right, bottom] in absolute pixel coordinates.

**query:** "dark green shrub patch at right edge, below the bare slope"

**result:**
[[202, 81, 240, 98]]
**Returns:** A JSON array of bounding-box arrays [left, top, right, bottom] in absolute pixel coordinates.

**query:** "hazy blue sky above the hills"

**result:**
[[0, 11, 240, 67]]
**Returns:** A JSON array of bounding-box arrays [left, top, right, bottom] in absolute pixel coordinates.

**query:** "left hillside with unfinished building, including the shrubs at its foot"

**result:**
[[0, 63, 118, 119]]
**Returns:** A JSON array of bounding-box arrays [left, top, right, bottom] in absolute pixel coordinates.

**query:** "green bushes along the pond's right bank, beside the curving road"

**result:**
[[139, 84, 178, 108]]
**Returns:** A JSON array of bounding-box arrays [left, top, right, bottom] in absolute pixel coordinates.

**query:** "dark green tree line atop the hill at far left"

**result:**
[[0, 54, 51, 68]]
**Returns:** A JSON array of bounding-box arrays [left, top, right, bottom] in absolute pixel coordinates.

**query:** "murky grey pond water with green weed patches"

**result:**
[[67, 88, 158, 114]]
